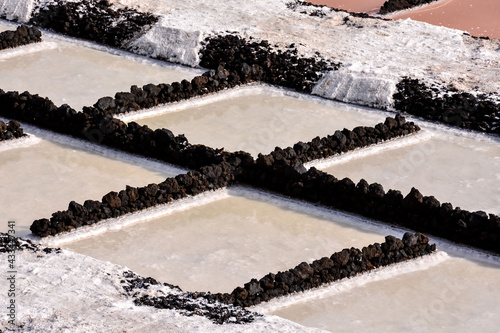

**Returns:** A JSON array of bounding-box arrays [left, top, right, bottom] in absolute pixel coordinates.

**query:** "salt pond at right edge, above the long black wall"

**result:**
[[312, 129, 500, 214]]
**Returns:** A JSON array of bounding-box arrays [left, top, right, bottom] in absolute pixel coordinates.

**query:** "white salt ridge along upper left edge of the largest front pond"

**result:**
[[36, 189, 228, 246]]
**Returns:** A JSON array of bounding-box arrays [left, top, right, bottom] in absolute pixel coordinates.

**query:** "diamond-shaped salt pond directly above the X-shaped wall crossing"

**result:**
[[123, 86, 386, 157]]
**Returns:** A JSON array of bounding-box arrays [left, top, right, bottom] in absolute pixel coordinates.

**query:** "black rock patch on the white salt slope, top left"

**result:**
[[30, 0, 158, 48]]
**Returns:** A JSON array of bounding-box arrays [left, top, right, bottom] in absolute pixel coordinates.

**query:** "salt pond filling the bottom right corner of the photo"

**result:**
[[262, 252, 500, 333]]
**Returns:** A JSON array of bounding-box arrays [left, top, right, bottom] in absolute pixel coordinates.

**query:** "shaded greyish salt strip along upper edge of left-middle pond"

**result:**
[[0, 117, 188, 174]]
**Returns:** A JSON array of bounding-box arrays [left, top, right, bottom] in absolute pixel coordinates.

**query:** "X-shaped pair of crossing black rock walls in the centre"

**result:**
[[0, 85, 494, 253]]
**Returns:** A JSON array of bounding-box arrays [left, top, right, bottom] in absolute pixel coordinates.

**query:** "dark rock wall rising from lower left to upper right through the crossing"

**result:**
[[24, 110, 419, 237]]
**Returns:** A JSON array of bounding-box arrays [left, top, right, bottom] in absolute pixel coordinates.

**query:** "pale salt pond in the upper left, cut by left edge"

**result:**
[[0, 35, 200, 110]]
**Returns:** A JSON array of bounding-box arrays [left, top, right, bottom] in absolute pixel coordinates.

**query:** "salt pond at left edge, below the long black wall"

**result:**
[[0, 132, 177, 237]]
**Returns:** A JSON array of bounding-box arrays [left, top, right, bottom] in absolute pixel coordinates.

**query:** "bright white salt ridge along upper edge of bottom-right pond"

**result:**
[[254, 251, 449, 314]]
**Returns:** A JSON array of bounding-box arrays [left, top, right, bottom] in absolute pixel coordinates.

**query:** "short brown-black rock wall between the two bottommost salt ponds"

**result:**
[[136, 232, 436, 308]]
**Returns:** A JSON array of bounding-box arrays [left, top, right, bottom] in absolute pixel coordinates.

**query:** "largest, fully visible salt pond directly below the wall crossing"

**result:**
[[65, 190, 392, 292]]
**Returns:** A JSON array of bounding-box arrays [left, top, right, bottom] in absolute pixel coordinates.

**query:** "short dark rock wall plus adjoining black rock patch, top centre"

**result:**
[[94, 35, 338, 114]]
